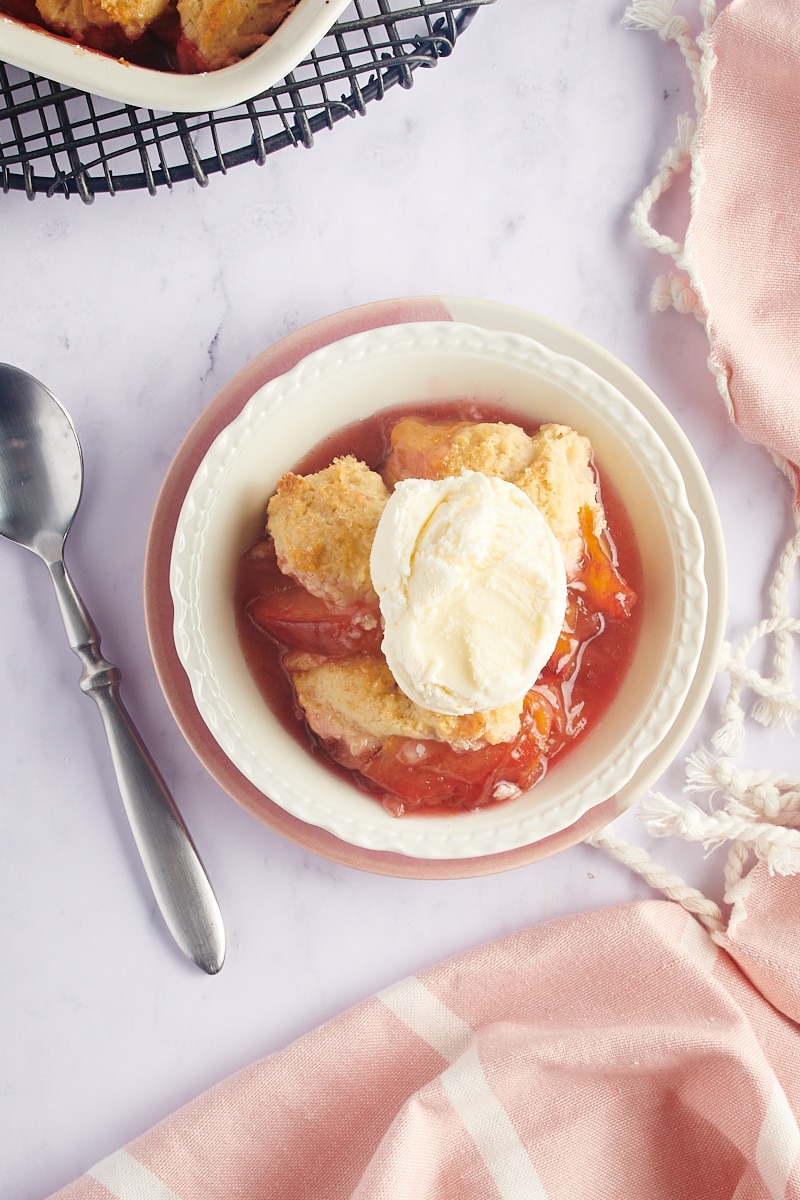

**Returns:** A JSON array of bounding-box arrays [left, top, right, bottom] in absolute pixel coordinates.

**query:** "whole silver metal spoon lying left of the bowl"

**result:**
[[0, 364, 225, 974]]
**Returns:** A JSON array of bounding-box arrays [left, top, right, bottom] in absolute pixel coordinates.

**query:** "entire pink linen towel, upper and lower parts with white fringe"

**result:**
[[47, 0, 800, 1200]]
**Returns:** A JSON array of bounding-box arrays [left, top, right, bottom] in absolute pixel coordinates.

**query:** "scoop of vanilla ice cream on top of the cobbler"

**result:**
[[369, 470, 566, 715]]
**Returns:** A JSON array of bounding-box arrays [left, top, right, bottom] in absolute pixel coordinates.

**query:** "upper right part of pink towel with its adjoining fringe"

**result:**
[[625, 0, 800, 496]]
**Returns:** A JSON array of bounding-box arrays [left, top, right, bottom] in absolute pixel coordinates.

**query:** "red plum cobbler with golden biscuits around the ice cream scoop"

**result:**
[[235, 404, 640, 816]]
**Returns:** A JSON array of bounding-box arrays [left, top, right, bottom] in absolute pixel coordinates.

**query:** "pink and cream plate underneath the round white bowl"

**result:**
[[144, 296, 726, 878]]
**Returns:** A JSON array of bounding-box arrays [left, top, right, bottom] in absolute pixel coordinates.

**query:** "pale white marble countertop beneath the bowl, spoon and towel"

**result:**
[[0, 0, 792, 1200]]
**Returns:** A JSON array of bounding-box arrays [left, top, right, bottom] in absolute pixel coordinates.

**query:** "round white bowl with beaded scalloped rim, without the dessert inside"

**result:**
[[170, 322, 708, 859]]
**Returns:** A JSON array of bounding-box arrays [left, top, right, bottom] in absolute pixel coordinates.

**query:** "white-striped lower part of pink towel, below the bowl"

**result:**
[[58, 897, 800, 1200]]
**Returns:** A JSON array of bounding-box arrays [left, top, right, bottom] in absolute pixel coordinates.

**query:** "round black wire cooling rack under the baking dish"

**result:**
[[0, 0, 494, 204]]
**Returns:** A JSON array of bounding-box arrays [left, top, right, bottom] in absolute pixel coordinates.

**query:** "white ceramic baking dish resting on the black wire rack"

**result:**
[[0, 0, 349, 113]]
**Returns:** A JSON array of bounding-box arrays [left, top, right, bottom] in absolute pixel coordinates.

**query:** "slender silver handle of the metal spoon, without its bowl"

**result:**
[[47, 558, 225, 974]]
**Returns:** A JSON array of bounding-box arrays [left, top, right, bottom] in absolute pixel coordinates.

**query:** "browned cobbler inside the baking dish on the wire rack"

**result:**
[[0, 0, 297, 74]]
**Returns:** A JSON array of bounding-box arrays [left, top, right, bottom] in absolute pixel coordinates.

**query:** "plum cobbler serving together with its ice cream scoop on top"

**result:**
[[235, 403, 640, 816]]
